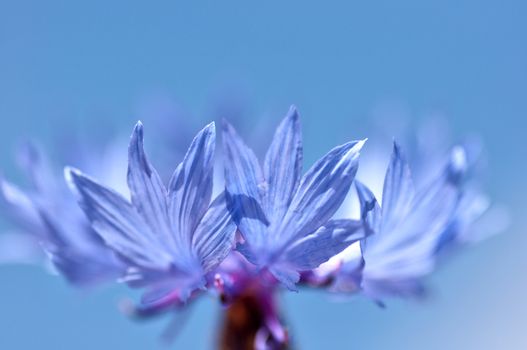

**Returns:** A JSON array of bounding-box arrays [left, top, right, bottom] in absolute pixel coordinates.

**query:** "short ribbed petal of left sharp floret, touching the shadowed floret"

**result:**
[[192, 193, 236, 272]]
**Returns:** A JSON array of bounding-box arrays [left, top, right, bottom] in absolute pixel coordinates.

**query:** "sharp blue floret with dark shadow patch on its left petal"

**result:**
[[223, 107, 364, 290]]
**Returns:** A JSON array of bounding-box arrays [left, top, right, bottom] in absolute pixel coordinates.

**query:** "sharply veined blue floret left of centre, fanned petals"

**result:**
[[67, 122, 236, 310]]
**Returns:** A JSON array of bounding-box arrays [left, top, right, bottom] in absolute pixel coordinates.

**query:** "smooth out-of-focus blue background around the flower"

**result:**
[[0, 0, 527, 349]]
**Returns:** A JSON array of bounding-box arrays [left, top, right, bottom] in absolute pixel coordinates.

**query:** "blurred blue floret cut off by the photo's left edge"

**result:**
[[0, 145, 124, 287]]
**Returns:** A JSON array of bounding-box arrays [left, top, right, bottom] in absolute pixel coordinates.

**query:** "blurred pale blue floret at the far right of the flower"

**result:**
[[350, 143, 466, 300]]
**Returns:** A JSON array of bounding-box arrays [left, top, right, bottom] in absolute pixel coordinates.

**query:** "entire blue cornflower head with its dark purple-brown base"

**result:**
[[0, 107, 506, 349]]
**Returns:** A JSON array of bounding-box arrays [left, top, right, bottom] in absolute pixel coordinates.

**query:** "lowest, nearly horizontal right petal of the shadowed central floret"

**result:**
[[284, 219, 365, 270]]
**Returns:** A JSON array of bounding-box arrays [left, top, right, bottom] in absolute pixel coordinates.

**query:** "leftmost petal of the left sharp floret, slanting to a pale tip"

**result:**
[[66, 168, 172, 270]]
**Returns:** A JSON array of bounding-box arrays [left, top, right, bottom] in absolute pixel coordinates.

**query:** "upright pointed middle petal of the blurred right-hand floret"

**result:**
[[382, 142, 415, 231]]
